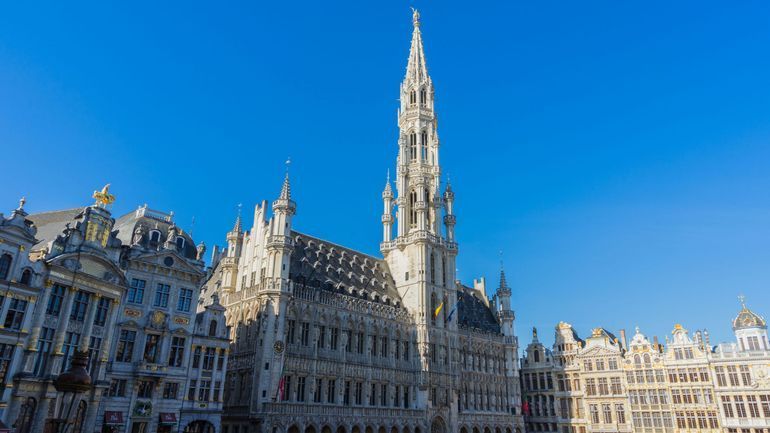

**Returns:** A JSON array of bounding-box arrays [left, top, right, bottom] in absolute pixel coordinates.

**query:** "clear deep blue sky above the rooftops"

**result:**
[[0, 1, 770, 345]]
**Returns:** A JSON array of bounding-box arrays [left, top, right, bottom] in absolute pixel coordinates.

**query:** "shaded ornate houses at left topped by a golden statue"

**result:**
[[0, 197, 229, 433]]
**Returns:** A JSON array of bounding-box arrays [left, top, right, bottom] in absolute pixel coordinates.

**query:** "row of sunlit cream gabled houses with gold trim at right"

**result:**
[[521, 304, 770, 433]]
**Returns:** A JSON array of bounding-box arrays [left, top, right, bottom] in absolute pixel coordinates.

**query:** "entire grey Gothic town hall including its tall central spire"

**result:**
[[195, 12, 523, 433]]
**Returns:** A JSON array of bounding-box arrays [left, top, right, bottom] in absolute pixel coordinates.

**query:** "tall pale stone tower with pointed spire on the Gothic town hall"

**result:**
[[380, 11, 457, 412]]
